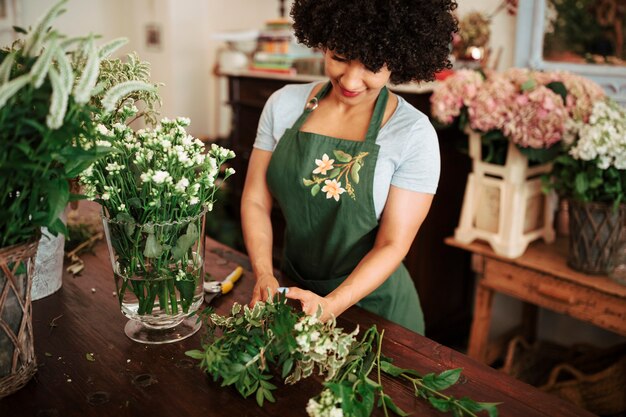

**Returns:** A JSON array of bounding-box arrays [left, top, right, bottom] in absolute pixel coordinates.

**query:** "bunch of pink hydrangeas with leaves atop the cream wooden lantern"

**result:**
[[431, 68, 605, 164]]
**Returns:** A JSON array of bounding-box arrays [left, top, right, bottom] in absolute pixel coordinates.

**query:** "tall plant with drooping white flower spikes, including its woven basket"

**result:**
[[0, 0, 153, 397]]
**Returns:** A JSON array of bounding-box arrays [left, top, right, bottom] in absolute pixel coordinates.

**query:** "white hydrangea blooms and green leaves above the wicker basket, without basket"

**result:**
[[544, 99, 626, 207]]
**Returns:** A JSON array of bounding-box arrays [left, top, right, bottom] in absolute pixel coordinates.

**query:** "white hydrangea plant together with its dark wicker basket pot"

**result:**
[[546, 99, 626, 274]]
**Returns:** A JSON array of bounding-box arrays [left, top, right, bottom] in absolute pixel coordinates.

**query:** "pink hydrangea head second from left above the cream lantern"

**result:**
[[467, 74, 517, 132]]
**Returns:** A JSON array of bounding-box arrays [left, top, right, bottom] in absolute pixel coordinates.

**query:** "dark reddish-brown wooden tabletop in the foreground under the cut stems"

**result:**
[[0, 234, 591, 417]]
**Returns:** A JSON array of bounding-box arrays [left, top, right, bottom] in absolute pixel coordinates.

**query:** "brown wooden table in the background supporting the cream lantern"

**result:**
[[446, 238, 626, 363]]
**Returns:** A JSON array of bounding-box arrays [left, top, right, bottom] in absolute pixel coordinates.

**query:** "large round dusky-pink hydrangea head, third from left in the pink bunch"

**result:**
[[502, 85, 568, 149]]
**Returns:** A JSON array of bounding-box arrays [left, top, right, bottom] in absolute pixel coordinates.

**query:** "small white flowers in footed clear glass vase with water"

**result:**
[[81, 105, 235, 343]]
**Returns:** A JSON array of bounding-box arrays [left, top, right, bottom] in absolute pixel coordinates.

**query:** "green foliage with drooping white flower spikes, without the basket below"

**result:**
[[0, 0, 153, 247]]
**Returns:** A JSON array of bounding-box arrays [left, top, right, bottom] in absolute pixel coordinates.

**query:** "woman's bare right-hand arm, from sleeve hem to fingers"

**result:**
[[287, 186, 433, 320]]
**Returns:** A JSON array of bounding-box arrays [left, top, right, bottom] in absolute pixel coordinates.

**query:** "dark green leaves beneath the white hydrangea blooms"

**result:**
[[542, 154, 626, 207]]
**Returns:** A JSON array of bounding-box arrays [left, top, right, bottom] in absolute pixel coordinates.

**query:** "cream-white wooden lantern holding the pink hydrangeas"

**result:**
[[454, 131, 556, 258]]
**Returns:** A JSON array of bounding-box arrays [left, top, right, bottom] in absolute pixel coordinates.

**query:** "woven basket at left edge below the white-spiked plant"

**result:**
[[0, 239, 38, 398]]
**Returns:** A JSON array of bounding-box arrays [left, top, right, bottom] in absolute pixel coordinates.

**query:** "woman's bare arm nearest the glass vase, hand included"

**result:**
[[241, 149, 278, 306]]
